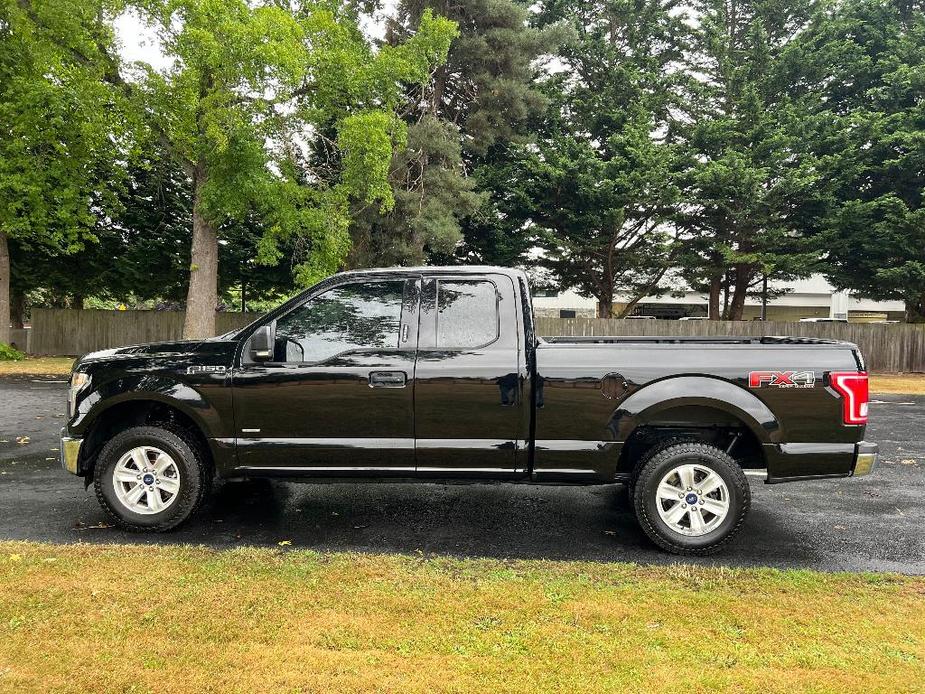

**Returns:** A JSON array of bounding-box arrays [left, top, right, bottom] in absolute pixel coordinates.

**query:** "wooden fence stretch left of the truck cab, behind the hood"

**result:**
[[29, 308, 259, 355]]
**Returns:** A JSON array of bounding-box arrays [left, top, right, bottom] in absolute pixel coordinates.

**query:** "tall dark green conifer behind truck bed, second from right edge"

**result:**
[[679, 0, 822, 320]]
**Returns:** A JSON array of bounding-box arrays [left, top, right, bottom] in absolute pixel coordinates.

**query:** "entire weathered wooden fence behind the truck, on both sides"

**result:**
[[30, 308, 925, 373]]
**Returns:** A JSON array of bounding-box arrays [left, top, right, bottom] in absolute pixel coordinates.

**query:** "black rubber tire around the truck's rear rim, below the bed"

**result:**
[[633, 441, 751, 556]]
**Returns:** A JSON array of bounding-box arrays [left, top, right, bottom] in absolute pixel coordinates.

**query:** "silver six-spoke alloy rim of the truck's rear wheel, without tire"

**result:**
[[655, 464, 729, 537]]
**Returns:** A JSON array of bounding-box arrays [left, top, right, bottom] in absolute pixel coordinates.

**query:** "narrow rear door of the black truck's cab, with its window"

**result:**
[[415, 274, 526, 477]]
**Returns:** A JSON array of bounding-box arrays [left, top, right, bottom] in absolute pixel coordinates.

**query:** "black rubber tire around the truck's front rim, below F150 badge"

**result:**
[[93, 425, 212, 532]]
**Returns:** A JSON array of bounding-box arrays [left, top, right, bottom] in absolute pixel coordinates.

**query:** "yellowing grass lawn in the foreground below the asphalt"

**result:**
[[0, 542, 925, 693]]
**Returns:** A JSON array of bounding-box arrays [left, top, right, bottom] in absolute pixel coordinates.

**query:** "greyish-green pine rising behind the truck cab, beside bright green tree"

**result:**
[[349, 0, 558, 267]]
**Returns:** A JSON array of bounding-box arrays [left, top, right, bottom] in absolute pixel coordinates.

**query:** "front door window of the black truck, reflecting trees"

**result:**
[[274, 280, 405, 362]]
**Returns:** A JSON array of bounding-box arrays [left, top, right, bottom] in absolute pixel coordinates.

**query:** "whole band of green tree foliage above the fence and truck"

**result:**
[[0, 0, 925, 326]]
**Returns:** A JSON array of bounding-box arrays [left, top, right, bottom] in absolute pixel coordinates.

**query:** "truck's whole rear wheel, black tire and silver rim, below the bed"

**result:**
[[633, 441, 751, 555]]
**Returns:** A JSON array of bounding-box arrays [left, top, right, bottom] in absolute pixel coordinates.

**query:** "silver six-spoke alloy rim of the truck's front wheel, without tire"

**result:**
[[112, 446, 180, 515]]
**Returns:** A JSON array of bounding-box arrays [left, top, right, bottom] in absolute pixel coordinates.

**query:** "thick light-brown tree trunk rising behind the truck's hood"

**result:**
[[183, 170, 218, 340]]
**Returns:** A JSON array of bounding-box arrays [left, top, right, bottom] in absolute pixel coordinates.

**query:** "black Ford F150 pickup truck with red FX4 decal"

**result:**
[[61, 267, 877, 554]]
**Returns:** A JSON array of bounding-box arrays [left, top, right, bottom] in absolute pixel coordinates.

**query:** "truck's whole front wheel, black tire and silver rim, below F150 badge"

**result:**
[[93, 426, 211, 532]]
